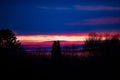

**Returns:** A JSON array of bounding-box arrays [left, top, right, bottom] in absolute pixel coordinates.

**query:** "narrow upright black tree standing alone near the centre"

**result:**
[[52, 41, 61, 61]]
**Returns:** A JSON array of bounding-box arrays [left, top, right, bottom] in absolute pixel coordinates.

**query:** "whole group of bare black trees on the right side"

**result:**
[[83, 32, 120, 57]]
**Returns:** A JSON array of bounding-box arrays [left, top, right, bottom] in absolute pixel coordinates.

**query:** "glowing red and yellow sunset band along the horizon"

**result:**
[[17, 32, 119, 47]]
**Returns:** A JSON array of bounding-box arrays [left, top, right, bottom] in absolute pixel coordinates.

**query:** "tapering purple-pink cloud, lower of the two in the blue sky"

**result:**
[[65, 17, 120, 26]]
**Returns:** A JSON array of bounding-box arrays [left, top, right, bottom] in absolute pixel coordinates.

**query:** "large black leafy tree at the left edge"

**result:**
[[0, 29, 24, 56]]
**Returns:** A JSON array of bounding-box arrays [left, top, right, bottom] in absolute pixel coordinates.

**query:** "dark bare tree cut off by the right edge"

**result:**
[[102, 34, 120, 56]]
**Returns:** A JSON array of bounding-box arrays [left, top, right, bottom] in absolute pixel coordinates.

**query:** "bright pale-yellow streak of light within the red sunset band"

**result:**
[[17, 35, 87, 42]]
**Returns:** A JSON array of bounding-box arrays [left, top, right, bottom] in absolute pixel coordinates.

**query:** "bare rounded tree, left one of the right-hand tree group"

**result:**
[[84, 32, 102, 56]]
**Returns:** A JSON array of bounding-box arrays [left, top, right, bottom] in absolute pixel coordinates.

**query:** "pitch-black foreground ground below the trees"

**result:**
[[4, 56, 117, 80]]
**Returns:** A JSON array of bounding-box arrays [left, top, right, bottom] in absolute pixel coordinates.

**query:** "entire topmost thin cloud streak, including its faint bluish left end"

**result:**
[[39, 5, 120, 11]]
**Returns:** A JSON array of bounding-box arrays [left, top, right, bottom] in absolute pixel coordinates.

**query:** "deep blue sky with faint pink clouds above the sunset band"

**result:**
[[0, 0, 120, 34]]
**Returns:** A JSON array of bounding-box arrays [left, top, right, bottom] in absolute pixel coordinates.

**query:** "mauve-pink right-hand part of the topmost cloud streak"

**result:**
[[74, 5, 120, 10]]
